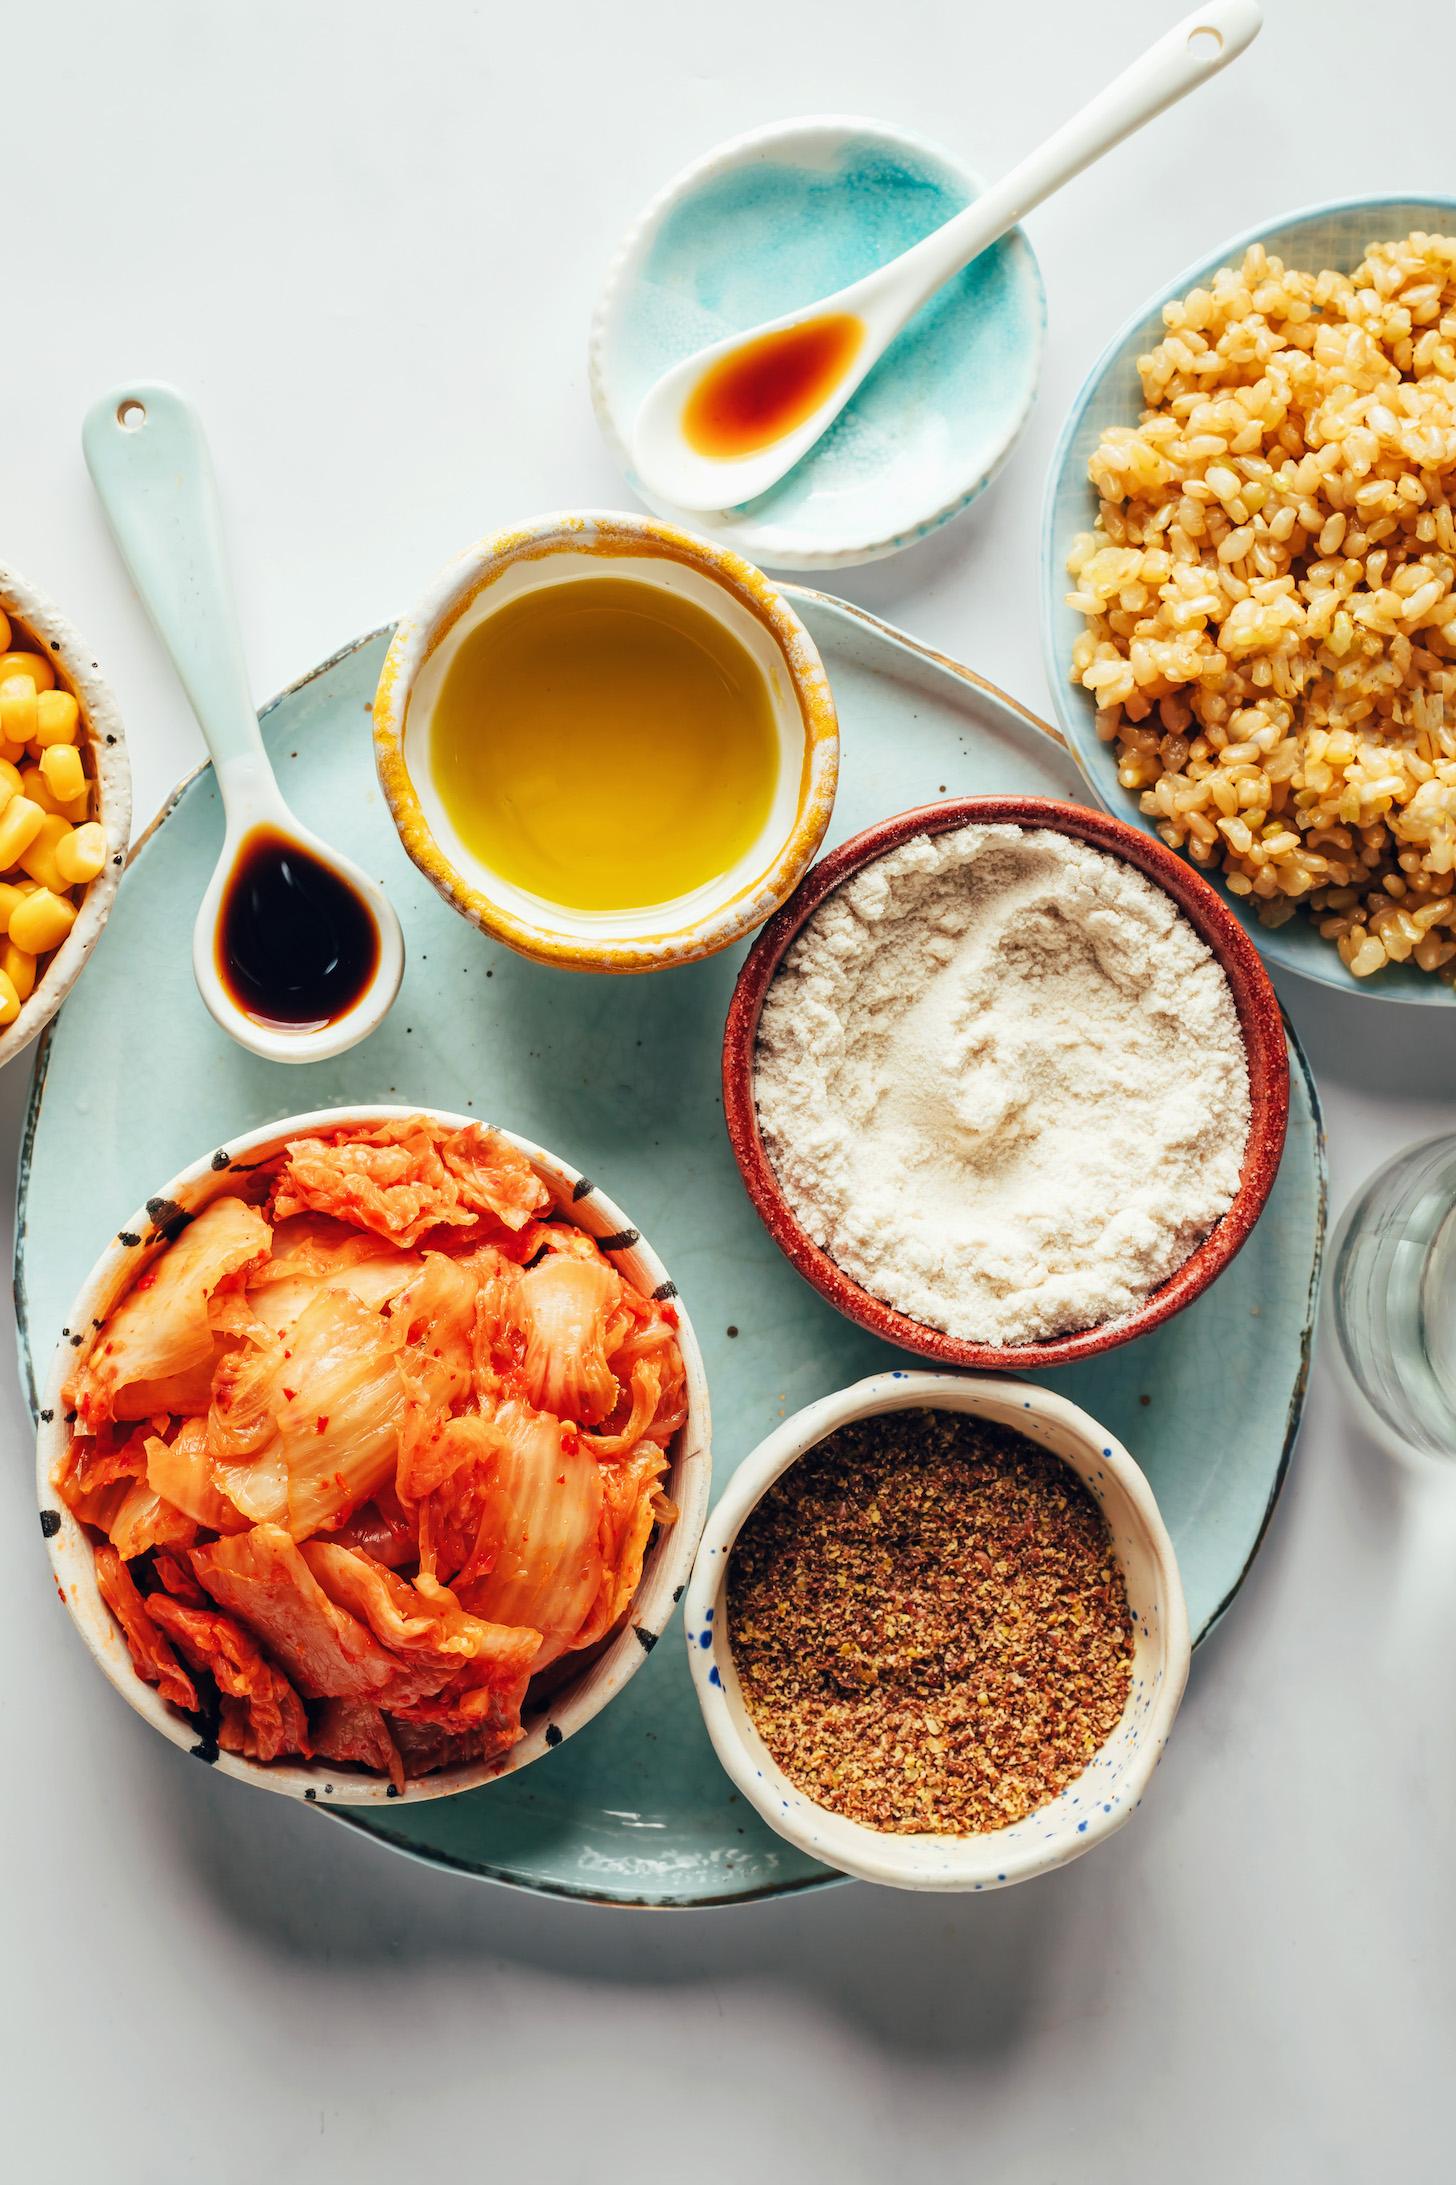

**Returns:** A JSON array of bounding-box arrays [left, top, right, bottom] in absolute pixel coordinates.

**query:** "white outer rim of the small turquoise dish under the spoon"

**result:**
[[588, 114, 1047, 570]]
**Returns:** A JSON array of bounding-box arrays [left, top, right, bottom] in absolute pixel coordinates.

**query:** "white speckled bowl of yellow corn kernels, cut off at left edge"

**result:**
[[0, 566, 131, 1064]]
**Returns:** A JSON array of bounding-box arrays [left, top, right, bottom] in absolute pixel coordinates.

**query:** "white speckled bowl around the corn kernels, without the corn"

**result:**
[[0, 566, 131, 1066]]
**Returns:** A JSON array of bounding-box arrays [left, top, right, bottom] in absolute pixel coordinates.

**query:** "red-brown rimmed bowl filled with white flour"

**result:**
[[724, 798, 1290, 1366]]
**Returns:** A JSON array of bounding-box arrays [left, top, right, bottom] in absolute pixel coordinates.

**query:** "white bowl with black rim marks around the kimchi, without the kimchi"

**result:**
[[37, 1103, 713, 1805]]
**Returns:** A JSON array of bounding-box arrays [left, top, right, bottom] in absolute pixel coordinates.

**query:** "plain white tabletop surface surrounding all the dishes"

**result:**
[[0, 0, 1456, 2185]]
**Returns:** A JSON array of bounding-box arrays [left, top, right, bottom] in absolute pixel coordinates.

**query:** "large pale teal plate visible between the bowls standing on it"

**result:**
[[15, 592, 1325, 1905]]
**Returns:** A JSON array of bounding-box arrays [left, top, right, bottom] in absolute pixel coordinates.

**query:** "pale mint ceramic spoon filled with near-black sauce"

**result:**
[[81, 382, 404, 1062]]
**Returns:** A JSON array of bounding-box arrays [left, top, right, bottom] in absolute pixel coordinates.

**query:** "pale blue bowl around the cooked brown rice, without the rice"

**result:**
[[1041, 197, 1456, 1009]]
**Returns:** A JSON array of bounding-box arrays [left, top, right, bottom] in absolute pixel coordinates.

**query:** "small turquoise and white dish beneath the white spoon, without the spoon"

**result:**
[[590, 116, 1045, 568]]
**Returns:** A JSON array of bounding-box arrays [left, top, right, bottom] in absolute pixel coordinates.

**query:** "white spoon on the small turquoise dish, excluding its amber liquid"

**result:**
[[632, 0, 1264, 509]]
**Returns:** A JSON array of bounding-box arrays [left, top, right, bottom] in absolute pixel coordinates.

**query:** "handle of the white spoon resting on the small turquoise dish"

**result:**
[[874, 0, 1264, 323]]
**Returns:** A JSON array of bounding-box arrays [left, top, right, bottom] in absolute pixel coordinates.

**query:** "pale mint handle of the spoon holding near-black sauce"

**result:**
[[81, 380, 271, 804]]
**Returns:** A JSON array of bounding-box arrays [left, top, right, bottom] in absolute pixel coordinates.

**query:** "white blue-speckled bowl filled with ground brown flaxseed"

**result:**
[[684, 1372, 1189, 1890]]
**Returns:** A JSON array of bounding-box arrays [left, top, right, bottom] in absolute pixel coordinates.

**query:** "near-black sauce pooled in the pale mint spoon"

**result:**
[[216, 826, 378, 1031]]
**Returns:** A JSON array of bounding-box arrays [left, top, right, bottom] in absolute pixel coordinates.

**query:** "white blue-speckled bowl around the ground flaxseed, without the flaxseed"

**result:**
[[682, 1372, 1189, 1890]]
